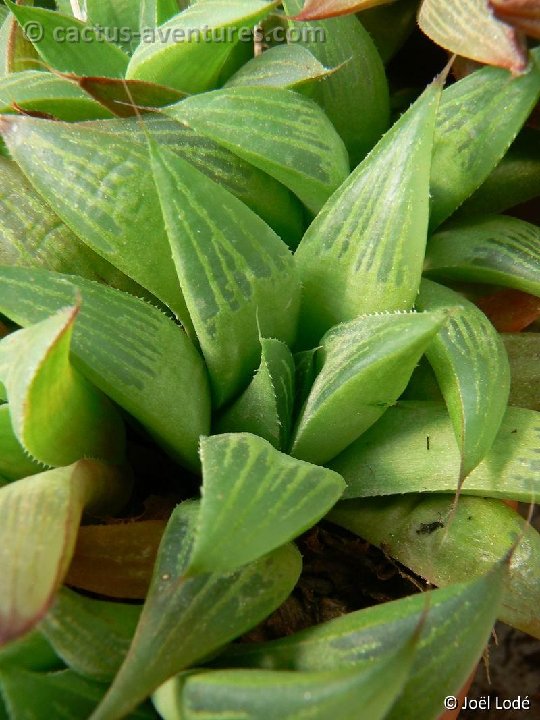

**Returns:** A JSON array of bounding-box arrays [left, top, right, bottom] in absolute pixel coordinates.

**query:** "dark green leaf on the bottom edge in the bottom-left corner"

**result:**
[[0, 669, 156, 720]]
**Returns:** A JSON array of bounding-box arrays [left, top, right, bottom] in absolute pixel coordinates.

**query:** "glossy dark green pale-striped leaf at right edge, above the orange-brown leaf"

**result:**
[[424, 215, 540, 296]]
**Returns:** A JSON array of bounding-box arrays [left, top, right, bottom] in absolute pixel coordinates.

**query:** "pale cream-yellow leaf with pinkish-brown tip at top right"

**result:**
[[418, 0, 527, 73]]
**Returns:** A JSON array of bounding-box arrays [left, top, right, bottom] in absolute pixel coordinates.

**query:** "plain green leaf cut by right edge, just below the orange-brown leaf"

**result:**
[[502, 332, 540, 411]]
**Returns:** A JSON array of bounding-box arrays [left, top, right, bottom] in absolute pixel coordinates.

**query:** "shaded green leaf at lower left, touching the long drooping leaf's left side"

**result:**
[[39, 588, 141, 682]]
